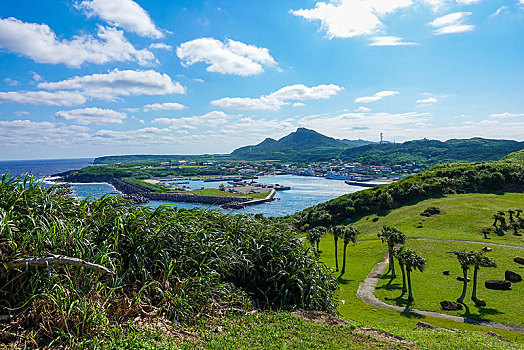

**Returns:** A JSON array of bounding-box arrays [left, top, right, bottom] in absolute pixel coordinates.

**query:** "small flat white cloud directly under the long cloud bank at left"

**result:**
[[55, 107, 127, 125]]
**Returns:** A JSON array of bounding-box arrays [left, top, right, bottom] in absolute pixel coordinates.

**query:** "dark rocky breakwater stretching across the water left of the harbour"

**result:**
[[109, 179, 250, 205]]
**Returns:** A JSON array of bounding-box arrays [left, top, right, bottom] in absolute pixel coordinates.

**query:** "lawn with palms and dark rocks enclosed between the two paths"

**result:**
[[375, 241, 524, 325]]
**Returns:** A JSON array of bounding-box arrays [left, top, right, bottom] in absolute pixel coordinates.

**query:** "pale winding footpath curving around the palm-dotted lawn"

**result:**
[[357, 238, 524, 333]]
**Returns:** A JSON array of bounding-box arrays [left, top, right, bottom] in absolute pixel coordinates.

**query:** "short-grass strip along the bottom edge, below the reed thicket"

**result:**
[[78, 312, 522, 350]]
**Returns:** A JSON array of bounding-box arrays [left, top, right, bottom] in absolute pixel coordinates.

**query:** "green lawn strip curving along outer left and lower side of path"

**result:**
[[314, 235, 524, 349]]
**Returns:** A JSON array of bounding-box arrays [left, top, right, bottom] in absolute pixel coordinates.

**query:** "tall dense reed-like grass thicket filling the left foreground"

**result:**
[[0, 176, 336, 346]]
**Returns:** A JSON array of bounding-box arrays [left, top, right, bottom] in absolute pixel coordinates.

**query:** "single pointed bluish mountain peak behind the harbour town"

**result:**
[[231, 128, 349, 162]]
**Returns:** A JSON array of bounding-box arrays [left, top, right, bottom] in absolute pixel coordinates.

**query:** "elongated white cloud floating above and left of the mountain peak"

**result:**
[[211, 84, 343, 110]]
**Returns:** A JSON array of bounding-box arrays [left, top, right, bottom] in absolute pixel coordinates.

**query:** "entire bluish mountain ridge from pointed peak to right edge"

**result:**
[[231, 128, 524, 169]]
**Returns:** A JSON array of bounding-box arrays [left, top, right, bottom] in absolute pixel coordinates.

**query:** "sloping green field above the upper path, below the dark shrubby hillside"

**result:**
[[355, 193, 524, 246]]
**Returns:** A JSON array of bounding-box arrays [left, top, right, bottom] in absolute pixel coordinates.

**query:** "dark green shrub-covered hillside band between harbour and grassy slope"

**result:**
[[294, 153, 524, 229]]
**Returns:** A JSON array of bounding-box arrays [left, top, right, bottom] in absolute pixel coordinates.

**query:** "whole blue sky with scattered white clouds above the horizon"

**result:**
[[0, 0, 524, 159]]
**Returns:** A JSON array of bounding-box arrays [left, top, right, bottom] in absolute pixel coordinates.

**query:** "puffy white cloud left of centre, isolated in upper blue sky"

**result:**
[[176, 38, 276, 76]]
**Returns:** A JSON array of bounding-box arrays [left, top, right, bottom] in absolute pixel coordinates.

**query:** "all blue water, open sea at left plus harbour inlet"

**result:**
[[0, 158, 363, 216]]
